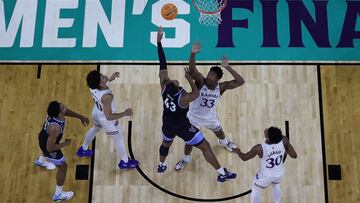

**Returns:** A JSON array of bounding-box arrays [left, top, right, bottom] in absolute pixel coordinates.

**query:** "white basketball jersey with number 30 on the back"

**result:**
[[259, 141, 285, 177]]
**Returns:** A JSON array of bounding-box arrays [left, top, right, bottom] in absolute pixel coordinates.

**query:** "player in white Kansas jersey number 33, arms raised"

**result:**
[[175, 43, 245, 170]]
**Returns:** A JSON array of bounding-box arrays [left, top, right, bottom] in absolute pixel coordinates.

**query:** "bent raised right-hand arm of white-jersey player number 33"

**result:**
[[220, 57, 245, 94]]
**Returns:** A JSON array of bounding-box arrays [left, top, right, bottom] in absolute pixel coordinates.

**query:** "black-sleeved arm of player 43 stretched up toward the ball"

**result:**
[[157, 26, 170, 89]]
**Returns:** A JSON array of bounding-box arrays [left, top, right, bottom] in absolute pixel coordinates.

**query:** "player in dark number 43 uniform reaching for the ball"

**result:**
[[157, 27, 236, 182]]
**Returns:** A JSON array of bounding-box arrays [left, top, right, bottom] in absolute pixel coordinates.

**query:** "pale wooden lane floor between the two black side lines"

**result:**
[[93, 65, 324, 202]]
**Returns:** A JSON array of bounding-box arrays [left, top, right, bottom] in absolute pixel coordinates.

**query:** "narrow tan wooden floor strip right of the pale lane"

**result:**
[[321, 65, 360, 203]]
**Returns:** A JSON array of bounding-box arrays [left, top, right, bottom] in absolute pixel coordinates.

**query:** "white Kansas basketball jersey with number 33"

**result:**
[[187, 84, 221, 120]]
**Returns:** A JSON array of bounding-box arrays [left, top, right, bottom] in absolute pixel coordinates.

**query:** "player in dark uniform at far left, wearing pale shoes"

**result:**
[[35, 101, 89, 201]]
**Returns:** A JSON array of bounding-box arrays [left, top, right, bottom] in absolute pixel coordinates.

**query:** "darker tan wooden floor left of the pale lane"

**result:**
[[0, 65, 96, 203]]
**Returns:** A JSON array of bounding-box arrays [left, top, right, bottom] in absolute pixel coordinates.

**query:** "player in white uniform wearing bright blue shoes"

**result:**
[[76, 70, 139, 169]]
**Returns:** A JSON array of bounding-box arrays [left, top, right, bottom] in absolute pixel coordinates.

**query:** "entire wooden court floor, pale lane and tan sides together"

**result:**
[[0, 65, 360, 202]]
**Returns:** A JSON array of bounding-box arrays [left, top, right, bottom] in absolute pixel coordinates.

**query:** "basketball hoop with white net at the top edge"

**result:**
[[192, 0, 227, 26]]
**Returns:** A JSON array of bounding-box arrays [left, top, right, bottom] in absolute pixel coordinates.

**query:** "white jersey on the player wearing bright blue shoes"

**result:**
[[90, 89, 116, 116]]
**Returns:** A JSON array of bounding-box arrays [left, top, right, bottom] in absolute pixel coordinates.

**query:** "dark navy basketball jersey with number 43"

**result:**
[[162, 84, 189, 124]]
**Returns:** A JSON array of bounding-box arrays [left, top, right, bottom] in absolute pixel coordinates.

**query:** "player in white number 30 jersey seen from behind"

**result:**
[[233, 127, 297, 203]]
